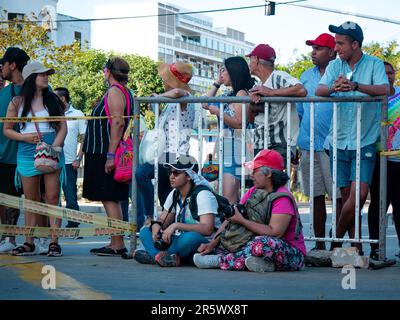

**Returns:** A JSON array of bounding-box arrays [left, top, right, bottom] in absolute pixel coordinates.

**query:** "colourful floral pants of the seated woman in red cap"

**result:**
[[216, 236, 304, 271]]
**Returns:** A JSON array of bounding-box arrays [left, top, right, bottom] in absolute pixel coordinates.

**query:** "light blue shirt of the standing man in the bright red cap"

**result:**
[[297, 66, 333, 151]]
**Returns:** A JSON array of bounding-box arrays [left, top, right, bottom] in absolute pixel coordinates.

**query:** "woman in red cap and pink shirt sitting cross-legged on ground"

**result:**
[[194, 150, 306, 272]]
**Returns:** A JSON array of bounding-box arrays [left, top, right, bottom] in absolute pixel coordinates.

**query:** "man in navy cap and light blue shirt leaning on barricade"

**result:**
[[316, 21, 389, 254]]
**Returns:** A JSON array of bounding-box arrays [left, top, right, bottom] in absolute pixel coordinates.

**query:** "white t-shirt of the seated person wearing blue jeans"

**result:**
[[164, 189, 218, 224]]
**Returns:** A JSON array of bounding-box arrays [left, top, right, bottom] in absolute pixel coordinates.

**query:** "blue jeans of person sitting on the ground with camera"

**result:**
[[140, 227, 208, 258]]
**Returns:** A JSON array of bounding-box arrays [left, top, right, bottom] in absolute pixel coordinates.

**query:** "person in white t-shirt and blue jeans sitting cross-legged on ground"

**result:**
[[134, 155, 218, 267]]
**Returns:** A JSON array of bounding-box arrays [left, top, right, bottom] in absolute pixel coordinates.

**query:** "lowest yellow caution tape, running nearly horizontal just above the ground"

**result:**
[[0, 224, 124, 238]]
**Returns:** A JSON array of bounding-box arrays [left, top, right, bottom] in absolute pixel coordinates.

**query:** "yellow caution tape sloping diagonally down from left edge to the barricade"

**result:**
[[0, 193, 136, 232]]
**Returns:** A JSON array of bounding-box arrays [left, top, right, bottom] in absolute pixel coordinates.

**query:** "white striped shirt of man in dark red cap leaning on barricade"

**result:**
[[254, 70, 302, 149]]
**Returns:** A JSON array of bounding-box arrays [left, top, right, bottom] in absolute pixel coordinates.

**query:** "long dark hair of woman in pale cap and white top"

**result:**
[[20, 73, 64, 129]]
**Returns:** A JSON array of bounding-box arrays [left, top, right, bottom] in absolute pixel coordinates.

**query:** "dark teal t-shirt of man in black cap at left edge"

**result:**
[[0, 84, 22, 164]]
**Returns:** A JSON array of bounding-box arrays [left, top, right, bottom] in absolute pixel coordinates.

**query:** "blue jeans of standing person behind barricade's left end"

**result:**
[[135, 163, 172, 217]]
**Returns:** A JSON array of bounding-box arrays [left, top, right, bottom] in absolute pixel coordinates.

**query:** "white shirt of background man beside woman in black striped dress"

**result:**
[[64, 105, 86, 164]]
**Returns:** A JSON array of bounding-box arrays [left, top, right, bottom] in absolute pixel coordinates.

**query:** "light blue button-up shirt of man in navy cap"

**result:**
[[320, 53, 389, 150]]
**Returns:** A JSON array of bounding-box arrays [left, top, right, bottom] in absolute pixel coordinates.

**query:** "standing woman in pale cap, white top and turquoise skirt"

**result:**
[[4, 62, 67, 256]]
